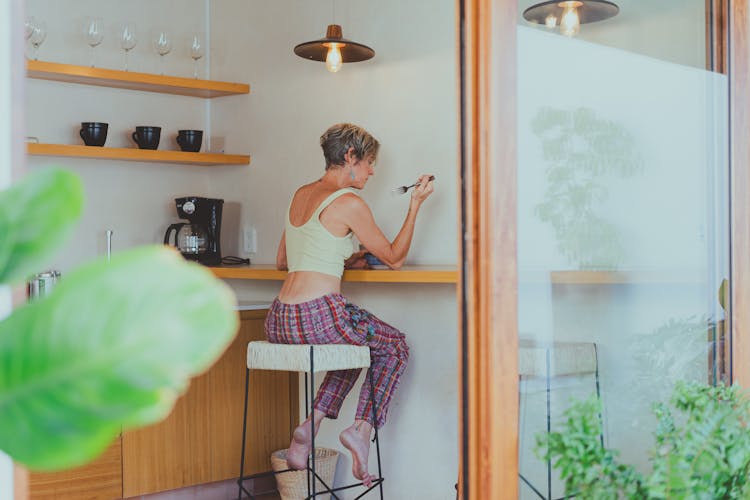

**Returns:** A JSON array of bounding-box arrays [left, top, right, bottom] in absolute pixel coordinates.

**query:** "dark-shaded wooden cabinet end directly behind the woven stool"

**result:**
[[210, 310, 299, 481]]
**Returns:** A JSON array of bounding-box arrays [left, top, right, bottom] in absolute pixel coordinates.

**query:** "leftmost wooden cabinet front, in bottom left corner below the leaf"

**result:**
[[29, 437, 122, 500]]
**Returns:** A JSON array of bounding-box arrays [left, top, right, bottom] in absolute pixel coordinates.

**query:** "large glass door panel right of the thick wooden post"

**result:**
[[518, 0, 729, 499]]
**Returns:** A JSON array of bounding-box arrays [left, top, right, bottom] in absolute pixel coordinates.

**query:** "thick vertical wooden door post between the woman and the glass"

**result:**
[[458, 0, 518, 500]]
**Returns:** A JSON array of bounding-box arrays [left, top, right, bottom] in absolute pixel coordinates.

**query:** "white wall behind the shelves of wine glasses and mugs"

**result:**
[[26, 0, 212, 276]]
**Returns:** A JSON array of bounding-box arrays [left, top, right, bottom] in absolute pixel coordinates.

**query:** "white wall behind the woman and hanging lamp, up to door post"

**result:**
[[210, 0, 458, 499]]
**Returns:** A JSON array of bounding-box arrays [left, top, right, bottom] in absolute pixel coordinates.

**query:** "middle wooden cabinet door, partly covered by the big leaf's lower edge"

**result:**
[[122, 373, 210, 498]]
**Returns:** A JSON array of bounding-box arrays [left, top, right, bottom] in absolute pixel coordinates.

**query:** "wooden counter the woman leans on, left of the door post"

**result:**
[[210, 264, 458, 283]]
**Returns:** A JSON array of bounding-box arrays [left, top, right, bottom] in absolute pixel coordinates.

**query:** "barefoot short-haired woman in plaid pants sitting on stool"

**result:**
[[265, 123, 433, 487]]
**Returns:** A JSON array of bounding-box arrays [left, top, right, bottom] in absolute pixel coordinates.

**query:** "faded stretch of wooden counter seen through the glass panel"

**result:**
[[549, 270, 705, 285]]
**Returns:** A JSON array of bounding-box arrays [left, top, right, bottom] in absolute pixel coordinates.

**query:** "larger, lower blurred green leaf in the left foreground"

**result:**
[[0, 247, 238, 470]]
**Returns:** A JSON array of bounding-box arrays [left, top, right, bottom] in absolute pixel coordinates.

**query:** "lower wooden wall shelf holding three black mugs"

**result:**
[[27, 143, 250, 165]]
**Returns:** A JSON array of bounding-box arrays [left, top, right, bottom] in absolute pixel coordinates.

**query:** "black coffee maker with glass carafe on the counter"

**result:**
[[164, 196, 224, 266]]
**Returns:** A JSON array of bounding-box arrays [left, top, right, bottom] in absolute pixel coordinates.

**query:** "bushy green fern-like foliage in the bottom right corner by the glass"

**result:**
[[537, 382, 750, 500]]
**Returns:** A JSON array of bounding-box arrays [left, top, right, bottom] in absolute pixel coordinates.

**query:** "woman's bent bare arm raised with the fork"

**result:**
[[347, 175, 434, 269]]
